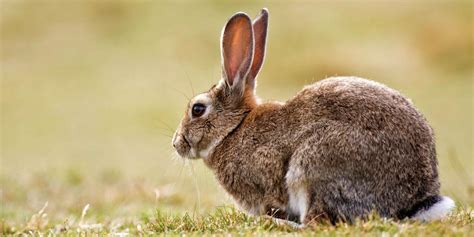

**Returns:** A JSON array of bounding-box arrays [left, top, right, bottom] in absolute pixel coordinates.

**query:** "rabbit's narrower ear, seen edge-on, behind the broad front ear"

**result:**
[[247, 8, 268, 89]]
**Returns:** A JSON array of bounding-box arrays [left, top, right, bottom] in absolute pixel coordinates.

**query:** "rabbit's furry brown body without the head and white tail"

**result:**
[[204, 77, 439, 222]]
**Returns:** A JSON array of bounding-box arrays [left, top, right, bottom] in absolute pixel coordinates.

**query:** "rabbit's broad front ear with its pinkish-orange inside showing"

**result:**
[[221, 12, 254, 89]]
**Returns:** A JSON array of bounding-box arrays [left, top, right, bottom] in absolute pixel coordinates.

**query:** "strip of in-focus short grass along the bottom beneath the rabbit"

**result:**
[[0, 205, 474, 236]]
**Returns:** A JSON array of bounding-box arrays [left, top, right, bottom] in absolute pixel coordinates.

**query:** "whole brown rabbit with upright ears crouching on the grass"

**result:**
[[172, 9, 455, 225]]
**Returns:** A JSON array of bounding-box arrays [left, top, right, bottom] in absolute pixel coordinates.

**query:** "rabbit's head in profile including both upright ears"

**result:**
[[173, 9, 268, 158]]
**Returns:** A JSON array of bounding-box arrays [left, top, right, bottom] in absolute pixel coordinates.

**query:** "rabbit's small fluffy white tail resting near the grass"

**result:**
[[412, 196, 456, 221]]
